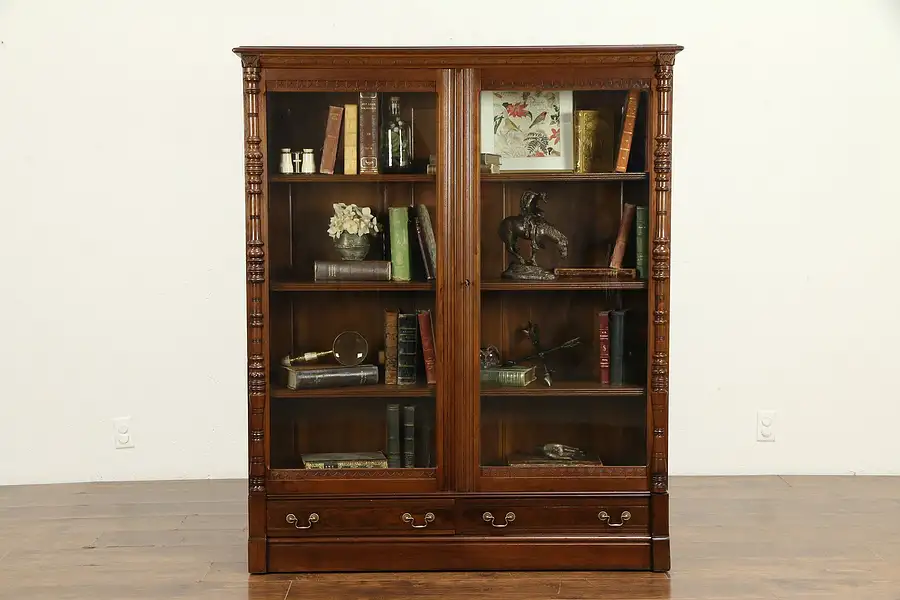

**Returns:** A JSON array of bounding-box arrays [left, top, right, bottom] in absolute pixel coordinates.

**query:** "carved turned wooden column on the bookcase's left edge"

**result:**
[[241, 55, 266, 493]]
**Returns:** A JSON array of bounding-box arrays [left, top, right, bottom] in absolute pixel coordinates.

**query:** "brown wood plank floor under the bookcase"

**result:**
[[0, 477, 900, 600]]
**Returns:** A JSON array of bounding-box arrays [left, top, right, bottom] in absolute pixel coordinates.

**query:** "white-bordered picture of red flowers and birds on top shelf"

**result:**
[[481, 90, 575, 171]]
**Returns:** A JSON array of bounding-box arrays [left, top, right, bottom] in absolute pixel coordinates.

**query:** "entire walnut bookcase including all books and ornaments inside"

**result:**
[[234, 45, 682, 573]]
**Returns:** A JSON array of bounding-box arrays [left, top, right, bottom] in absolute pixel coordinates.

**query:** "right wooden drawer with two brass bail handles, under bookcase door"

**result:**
[[456, 497, 650, 536]]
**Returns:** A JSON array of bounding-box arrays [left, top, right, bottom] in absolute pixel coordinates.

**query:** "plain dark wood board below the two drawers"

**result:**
[[269, 536, 650, 572]]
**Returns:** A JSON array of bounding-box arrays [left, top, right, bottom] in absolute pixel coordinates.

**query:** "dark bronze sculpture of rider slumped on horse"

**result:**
[[497, 191, 569, 281]]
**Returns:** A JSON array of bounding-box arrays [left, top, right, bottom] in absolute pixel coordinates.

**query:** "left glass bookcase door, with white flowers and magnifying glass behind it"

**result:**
[[266, 79, 439, 492]]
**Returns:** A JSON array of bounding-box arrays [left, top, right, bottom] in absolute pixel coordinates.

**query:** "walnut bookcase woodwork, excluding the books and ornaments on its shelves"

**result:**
[[234, 46, 681, 573]]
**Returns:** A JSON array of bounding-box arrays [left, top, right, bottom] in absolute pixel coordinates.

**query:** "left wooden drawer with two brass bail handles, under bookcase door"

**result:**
[[267, 499, 454, 537]]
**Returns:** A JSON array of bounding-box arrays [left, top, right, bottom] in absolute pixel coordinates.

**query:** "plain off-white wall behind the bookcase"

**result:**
[[0, 0, 900, 484]]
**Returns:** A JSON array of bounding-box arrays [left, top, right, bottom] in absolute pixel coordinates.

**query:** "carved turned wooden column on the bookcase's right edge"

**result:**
[[650, 53, 675, 493]]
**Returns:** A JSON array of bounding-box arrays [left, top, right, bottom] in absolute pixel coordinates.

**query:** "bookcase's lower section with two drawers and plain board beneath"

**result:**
[[261, 494, 669, 572]]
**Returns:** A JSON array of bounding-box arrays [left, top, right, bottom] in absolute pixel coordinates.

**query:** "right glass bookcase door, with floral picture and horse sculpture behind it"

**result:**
[[477, 84, 650, 491]]
